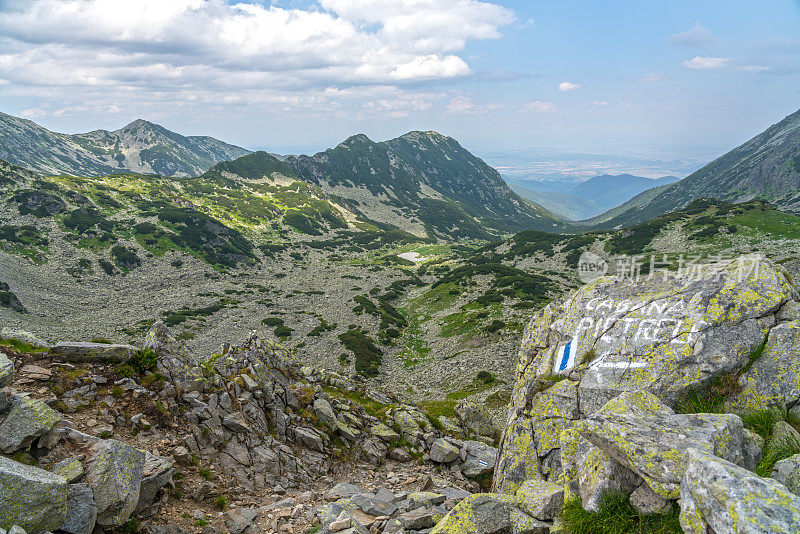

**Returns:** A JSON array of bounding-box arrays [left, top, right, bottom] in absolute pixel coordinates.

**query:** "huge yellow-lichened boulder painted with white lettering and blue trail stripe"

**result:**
[[493, 257, 798, 494]]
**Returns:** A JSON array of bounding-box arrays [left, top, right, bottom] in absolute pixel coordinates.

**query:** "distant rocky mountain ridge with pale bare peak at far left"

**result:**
[[0, 113, 248, 176]]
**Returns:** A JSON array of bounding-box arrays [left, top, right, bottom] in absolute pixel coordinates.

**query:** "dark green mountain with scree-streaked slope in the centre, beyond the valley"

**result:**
[[286, 132, 563, 239]]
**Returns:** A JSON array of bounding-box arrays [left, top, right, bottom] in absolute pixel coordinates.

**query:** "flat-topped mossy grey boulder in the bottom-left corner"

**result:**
[[0, 456, 67, 532]]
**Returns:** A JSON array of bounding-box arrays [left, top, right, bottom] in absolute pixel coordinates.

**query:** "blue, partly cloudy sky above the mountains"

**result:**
[[0, 0, 800, 165]]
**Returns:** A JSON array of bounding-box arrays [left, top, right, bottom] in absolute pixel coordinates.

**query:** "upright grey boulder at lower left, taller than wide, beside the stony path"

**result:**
[[86, 439, 145, 526]]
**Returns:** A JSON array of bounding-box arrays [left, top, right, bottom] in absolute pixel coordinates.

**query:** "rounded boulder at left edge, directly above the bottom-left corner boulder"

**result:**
[[0, 397, 61, 454]]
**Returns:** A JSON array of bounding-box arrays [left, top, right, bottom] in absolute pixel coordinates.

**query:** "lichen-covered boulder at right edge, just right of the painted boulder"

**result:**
[[728, 320, 800, 413]]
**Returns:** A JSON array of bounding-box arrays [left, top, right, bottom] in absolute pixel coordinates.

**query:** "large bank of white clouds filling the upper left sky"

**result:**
[[0, 0, 514, 113]]
